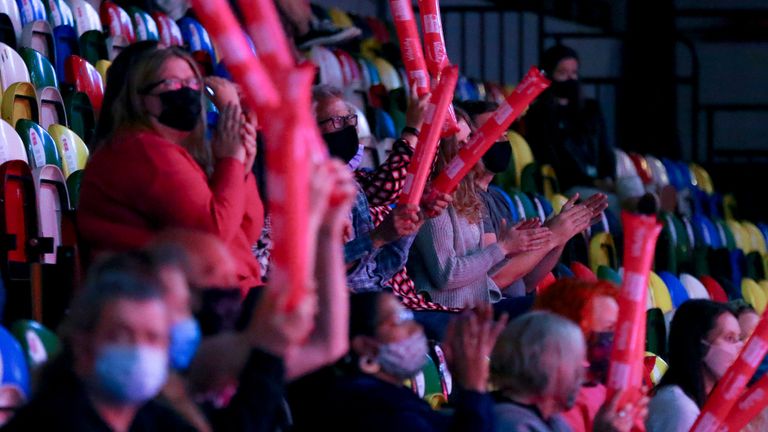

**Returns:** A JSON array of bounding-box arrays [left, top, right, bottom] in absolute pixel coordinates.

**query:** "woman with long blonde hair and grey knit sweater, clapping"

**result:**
[[408, 111, 552, 316]]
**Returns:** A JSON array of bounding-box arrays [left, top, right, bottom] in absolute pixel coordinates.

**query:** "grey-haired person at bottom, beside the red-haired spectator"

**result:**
[[491, 312, 648, 432]]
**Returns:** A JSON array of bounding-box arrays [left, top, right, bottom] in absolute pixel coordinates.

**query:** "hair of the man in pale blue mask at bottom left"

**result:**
[[62, 252, 162, 340]]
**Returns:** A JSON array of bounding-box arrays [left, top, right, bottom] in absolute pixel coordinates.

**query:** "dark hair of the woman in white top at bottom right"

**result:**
[[659, 300, 733, 408]]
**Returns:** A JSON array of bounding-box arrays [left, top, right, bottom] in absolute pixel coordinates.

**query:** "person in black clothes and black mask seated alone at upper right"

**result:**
[[522, 45, 644, 211]]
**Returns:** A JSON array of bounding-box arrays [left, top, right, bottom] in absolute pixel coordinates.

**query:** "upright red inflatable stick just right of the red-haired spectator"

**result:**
[[606, 212, 661, 405]]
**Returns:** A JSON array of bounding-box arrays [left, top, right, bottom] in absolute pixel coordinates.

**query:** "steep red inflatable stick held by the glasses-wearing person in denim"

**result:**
[[400, 66, 459, 205]]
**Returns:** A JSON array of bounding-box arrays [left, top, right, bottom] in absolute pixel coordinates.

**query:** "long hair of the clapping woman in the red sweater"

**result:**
[[95, 47, 213, 175]]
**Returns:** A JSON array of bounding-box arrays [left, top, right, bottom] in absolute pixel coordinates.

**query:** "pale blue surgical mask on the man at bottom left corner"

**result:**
[[90, 344, 168, 404]]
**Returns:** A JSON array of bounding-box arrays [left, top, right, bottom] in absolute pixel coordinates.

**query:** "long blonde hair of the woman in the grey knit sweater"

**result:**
[[433, 108, 483, 224]]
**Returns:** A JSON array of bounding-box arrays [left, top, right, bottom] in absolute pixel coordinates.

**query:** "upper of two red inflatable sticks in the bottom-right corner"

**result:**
[[691, 311, 768, 432]]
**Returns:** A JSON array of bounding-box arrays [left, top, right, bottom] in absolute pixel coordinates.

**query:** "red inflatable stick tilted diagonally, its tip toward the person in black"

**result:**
[[433, 67, 550, 193]]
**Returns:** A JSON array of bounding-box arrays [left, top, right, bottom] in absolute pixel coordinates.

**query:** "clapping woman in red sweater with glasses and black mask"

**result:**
[[78, 44, 264, 291]]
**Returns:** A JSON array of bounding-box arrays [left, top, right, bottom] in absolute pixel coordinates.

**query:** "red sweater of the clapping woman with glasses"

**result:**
[[77, 131, 264, 290]]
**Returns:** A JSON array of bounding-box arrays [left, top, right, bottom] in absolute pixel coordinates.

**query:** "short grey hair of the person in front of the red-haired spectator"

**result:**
[[491, 312, 584, 396]]
